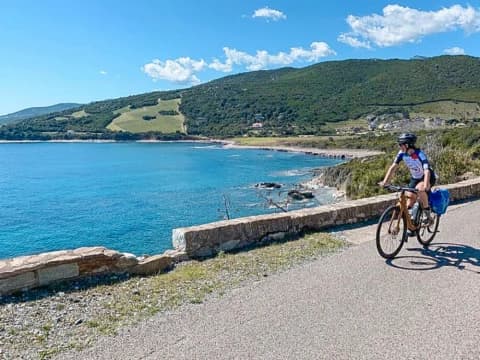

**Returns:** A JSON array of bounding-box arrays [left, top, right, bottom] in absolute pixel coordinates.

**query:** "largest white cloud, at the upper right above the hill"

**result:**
[[338, 5, 480, 47]]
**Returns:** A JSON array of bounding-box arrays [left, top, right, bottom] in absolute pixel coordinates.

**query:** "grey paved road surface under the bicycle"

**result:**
[[62, 201, 480, 359]]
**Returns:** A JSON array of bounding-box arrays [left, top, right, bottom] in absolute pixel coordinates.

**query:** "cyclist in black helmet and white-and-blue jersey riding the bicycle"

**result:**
[[378, 133, 436, 228]]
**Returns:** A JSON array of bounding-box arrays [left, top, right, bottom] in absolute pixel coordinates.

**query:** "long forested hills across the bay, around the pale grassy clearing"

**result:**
[[0, 56, 480, 138]]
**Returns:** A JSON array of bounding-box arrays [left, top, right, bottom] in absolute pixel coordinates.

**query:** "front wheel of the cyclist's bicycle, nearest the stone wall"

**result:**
[[376, 205, 407, 259]]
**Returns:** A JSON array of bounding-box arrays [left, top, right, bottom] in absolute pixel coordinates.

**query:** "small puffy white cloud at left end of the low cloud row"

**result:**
[[142, 57, 207, 84]]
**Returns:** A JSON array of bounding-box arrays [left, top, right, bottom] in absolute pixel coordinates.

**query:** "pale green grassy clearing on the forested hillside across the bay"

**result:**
[[107, 99, 185, 134]]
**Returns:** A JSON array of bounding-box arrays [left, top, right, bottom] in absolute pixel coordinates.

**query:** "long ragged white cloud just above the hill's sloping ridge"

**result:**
[[209, 42, 336, 72]]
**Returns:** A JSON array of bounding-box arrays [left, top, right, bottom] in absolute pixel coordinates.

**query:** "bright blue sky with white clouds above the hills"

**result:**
[[0, 0, 480, 114]]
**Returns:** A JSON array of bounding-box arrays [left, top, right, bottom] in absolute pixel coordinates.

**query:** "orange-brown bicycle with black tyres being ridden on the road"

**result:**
[[376, 185, 440, 259]]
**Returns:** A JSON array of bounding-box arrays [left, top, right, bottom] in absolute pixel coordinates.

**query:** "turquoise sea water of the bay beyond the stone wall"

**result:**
[[0, 143, 338, 258]]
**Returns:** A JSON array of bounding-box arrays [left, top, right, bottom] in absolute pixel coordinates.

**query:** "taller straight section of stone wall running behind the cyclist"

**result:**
[[173, 178, 480, 258]]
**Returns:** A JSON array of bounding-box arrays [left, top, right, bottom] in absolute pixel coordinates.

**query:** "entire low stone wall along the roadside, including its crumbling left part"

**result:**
[[0, 178, 480, 295]]
